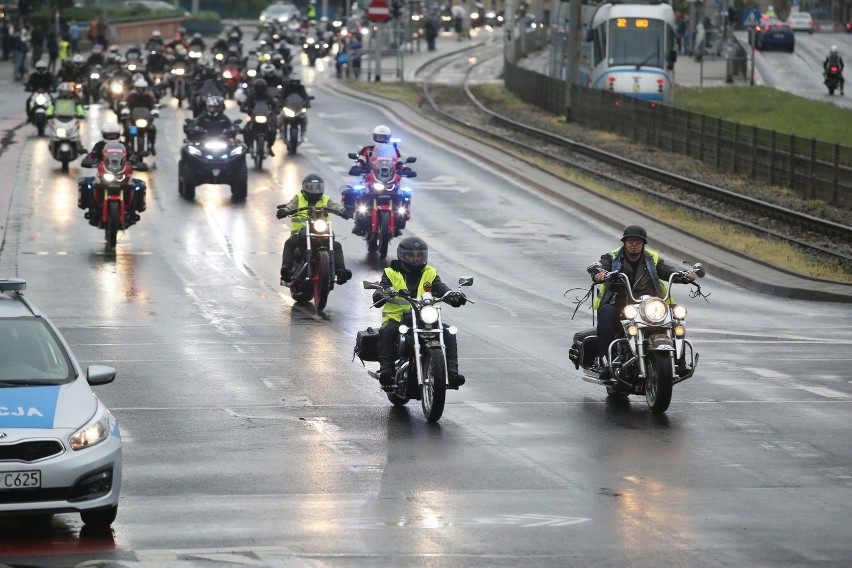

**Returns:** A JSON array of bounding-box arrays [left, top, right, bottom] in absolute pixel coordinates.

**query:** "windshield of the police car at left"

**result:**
[[0, 317, 74, 384]]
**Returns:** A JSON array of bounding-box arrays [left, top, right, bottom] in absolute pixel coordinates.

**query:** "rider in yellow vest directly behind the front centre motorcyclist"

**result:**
[[276, 174, 352, 286]]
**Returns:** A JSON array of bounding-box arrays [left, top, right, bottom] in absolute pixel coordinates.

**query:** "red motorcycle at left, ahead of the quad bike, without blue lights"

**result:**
[[77, 141, 148, 248]]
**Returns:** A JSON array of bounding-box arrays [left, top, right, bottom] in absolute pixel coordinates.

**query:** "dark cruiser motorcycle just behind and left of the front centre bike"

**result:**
[[278, 205, 350, 310]]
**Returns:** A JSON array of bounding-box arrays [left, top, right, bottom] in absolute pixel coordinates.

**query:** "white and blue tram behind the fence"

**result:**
[[584, 0, 677, 104]]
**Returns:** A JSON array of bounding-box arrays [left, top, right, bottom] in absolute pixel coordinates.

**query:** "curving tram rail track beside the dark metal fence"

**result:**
[[416, 44, 852, 266]]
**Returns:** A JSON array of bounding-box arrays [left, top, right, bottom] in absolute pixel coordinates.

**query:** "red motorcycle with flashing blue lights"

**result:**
[[341, 145, 417, 258]]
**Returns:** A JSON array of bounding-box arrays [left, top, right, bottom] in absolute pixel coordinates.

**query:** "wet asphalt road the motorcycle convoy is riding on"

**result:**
[[0, 48, 852, 567]]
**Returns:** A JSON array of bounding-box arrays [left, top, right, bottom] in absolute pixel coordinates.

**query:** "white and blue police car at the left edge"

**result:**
[[0, 280, 121, 526]]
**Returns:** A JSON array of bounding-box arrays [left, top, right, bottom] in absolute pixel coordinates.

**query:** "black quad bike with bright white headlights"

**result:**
[[178, 118, 248, 202]]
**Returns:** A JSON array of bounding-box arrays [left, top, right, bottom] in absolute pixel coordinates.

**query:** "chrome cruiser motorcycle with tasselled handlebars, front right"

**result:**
[[568, 263, 706, 413]]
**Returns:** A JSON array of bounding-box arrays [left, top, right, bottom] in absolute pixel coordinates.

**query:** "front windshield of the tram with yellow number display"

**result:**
[[608, 18, 666, 69]]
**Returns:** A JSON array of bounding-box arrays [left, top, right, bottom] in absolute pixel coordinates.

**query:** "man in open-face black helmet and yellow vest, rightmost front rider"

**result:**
[[592, 225, 696, 379]]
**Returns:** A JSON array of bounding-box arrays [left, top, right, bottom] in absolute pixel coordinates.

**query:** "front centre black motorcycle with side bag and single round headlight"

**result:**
[[355, 278, 474, 422]]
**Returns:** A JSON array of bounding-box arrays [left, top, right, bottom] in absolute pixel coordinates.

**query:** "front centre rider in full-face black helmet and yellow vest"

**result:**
[[373, 237, 467, 391]]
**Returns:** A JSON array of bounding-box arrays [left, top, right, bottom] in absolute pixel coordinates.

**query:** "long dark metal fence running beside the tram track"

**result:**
[[504, 35, 852, 207]]
